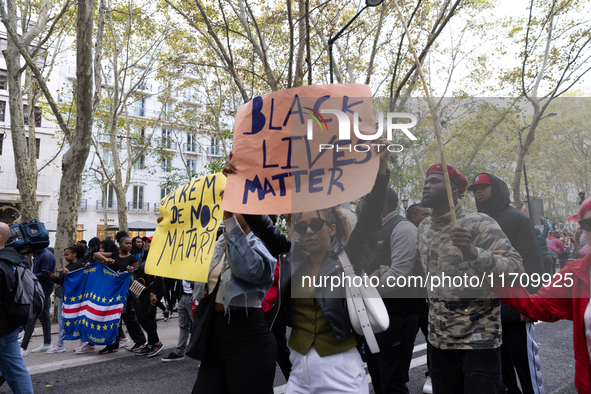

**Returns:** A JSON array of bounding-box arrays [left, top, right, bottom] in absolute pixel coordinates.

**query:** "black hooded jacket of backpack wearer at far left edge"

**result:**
[[0, 248, 30, 337]]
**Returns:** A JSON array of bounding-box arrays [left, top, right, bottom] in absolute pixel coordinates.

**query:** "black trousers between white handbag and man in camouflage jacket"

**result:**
[[365, 313, 419, 394]]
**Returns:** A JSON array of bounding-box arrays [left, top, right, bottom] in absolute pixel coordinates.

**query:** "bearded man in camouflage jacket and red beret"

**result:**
[[417, 164, 523, 394]]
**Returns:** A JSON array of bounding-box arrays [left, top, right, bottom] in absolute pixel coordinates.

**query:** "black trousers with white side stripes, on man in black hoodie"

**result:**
[[501, 323, 542, 394]]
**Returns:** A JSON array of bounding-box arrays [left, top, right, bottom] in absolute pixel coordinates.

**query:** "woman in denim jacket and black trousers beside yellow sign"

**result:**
[[193, 212, 277, 394]]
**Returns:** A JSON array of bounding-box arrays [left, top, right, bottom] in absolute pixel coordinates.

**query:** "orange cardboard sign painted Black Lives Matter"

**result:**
[[223, 84, 385, 214]]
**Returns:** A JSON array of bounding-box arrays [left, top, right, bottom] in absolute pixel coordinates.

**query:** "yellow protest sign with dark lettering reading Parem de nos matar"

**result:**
[[146, 173, 226, 282]]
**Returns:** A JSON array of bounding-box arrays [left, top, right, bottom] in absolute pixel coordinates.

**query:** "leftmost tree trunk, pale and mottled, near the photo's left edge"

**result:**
[[4, 1, 39, 221]]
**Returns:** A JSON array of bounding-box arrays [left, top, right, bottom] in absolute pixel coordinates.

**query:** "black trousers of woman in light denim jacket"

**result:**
[[193, 308, 277, 394]]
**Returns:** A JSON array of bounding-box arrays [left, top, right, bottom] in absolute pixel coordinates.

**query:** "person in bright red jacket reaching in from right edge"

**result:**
[[492, 197, 591, 393]]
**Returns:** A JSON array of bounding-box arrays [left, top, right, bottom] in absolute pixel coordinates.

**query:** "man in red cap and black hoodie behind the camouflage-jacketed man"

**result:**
[[468, 173, 544, 394]]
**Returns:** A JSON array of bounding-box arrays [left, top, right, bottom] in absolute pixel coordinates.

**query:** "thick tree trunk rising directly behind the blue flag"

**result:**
[[55, 0, 94, 267]]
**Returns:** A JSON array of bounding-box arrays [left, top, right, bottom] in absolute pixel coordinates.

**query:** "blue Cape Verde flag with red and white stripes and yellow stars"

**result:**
[[60, 261, 129, 345]]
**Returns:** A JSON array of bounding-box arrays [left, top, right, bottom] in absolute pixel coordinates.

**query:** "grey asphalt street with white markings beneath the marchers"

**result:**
[[0, 315, 576, 394]]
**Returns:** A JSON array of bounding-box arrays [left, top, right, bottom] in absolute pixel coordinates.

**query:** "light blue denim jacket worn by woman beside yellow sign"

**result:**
[[193, 218, 277, 313]]
